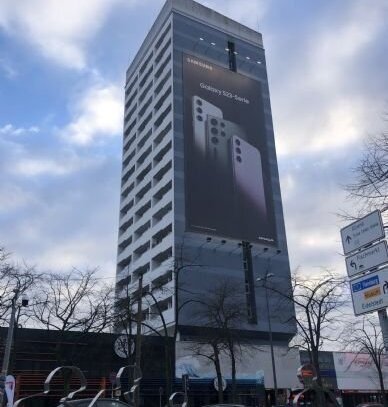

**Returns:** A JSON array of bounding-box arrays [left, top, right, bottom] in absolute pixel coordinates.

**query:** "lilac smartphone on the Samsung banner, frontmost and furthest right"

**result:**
[[231, 135, 267, 239]]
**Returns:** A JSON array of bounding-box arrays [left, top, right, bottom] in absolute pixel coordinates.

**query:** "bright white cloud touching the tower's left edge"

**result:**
[[60, 85, 123, 146]]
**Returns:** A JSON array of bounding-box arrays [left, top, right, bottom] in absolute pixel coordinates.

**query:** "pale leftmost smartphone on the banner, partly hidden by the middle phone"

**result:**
[[193, 96, 222, 158]]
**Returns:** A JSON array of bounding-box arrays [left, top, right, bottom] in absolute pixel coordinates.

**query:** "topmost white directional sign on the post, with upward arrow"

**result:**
[[341, 211, 385, 254]]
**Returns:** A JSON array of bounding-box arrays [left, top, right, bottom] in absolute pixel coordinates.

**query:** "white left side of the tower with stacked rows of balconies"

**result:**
[[118, 24, 172, 300]]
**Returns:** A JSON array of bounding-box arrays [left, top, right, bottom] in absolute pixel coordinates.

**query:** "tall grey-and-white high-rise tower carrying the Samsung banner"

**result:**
[[116, 0, 295, 342]]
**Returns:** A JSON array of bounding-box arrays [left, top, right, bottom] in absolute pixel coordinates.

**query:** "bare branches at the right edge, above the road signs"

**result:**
[[344, 120, 388, 217]]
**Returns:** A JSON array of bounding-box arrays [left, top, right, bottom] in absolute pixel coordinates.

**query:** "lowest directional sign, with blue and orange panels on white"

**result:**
[[350, 268, 388, 315]]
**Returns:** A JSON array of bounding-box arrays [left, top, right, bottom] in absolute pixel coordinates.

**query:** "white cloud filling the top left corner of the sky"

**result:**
[[0, 0, 137, 69]]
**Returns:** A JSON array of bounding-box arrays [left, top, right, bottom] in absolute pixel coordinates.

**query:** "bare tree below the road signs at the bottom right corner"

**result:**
[[342, 315, 388, 407]]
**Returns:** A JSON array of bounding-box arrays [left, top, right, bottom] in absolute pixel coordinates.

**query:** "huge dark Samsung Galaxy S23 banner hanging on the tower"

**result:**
[[183, 54, 276, 245]]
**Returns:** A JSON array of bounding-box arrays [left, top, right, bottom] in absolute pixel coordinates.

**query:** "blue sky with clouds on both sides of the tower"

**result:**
[[0, 0, 388, 276]]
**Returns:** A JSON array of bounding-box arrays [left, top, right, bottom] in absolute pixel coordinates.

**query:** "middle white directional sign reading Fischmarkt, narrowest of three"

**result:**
[[345, 240, 388, 277]]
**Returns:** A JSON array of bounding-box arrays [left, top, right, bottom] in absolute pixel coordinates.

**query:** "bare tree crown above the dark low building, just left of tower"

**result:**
[[33, 269, 113, 332]]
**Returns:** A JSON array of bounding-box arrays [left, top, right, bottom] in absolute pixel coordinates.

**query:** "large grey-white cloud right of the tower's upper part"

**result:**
[[270, 0, 388, 155]]
